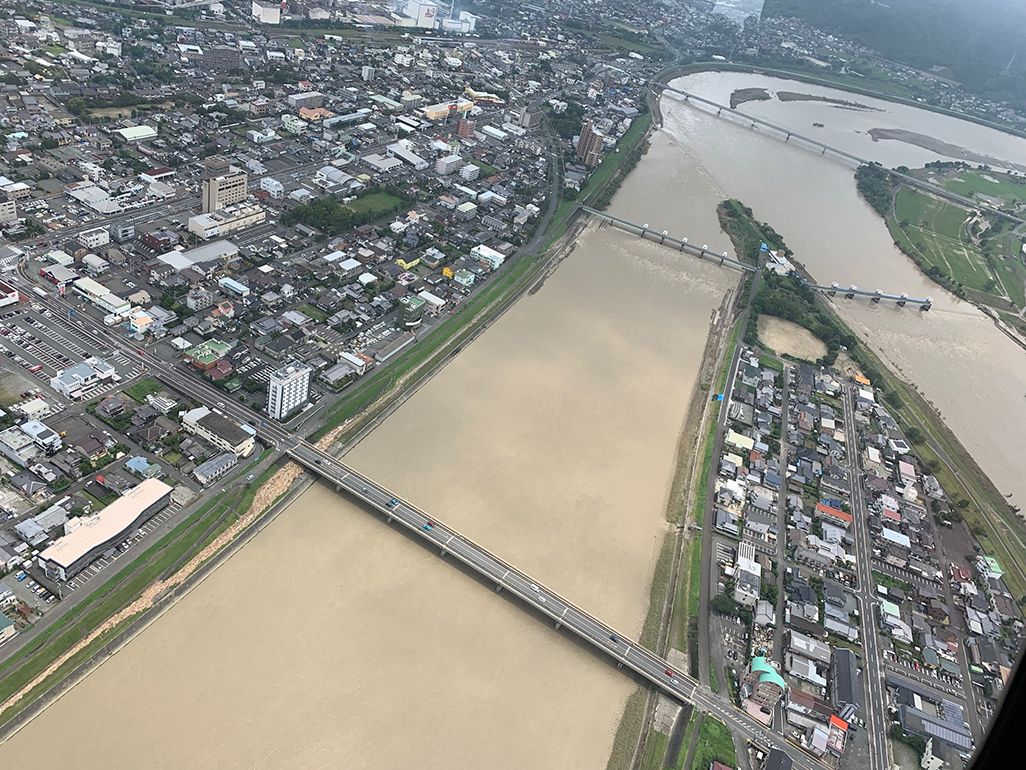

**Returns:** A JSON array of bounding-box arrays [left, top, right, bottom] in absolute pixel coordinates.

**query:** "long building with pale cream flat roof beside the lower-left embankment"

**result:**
[[38, 478, 173, 580]]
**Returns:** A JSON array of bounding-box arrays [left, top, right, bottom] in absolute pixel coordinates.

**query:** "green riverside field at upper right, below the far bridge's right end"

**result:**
[[892, 187, 994, 293]]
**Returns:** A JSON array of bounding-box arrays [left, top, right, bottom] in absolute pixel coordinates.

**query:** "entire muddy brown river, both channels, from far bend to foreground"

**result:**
[[0, 74, 1026, 770]]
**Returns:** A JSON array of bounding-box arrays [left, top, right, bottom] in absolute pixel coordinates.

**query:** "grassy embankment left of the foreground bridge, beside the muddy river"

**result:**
[[0, 451, 276, 725]]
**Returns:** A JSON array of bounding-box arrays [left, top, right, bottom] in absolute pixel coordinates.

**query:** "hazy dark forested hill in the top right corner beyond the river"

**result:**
[[762, 0, 1026, 106]]
